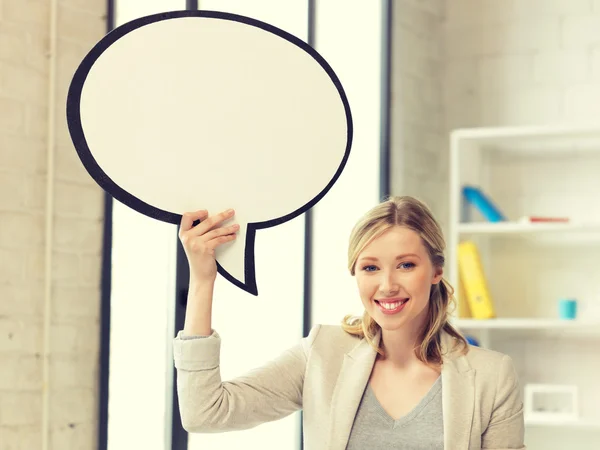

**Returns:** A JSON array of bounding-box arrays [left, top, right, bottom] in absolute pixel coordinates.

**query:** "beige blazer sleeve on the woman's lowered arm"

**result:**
[[481, 355, 526, 450]]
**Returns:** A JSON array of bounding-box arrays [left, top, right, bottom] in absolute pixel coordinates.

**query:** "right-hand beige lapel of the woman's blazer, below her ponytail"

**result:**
[[442, 333, 475, 450]]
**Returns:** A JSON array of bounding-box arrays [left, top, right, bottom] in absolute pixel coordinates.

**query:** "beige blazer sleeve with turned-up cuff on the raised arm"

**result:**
[[173, 325, 320, 433]]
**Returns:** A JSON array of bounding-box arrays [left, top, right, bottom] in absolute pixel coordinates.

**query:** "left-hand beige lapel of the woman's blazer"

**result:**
[[326, 335, 380, 450]]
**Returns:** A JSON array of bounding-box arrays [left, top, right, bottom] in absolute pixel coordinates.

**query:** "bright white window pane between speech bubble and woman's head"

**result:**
[[312, 0, 383, 324]]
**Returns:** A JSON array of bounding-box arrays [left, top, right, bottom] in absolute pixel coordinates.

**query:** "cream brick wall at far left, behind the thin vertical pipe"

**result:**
[[0, 0, 106, 450]]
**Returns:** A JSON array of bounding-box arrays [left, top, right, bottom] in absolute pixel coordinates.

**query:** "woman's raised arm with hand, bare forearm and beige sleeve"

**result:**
[[173, 211, 318, 432]]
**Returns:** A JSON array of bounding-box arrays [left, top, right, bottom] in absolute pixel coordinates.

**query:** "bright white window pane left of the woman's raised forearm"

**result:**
[[108, 0, 185, 450]]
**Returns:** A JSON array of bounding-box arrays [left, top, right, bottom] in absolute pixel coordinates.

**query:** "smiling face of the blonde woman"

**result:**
[[355, 225, 443, 333]]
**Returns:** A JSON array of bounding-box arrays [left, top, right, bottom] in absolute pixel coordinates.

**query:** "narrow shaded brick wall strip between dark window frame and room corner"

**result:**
[[390, 0, 447, 227]]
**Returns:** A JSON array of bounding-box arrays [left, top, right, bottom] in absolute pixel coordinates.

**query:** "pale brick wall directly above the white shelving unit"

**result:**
[[443, 0, 600, 131]]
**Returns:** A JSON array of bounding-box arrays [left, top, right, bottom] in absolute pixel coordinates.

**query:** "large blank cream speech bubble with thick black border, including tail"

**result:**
[[67, 11, 352, 295]]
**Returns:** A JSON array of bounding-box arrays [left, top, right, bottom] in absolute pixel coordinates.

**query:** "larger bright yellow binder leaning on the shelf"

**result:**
[[458, 241, 496, 319]]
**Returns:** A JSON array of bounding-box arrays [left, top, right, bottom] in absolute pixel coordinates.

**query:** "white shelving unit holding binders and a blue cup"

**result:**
[[446, 124, 600, 448]]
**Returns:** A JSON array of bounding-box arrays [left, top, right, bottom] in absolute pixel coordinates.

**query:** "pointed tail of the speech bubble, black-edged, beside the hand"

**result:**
[[217, 224, 258, 296]]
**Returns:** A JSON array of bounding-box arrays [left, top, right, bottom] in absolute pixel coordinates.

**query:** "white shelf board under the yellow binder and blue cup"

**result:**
[[452, 318, 600, 334]]
